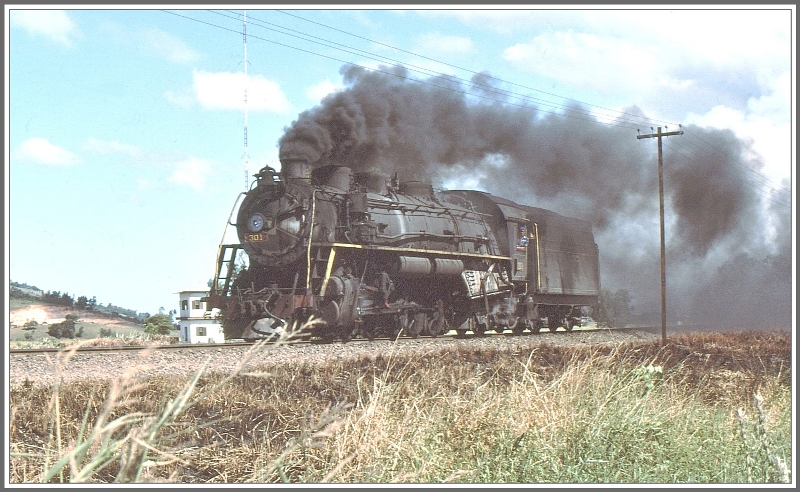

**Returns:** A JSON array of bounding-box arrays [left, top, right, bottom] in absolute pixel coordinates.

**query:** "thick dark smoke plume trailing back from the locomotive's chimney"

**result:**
[[279, 63, 792, 328]]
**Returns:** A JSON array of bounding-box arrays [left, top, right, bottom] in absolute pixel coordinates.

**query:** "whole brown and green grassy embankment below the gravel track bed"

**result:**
[[9, 332, 792, 483]]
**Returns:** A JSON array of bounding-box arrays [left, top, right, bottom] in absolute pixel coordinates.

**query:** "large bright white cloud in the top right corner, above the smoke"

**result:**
[[424, 7, 793, 137]]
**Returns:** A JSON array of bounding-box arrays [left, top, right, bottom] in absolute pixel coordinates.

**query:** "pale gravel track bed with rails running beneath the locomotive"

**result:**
[[7, 327, 659, 386]]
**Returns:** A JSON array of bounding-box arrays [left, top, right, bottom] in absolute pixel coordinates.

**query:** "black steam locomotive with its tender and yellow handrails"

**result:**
[[206, 161, 600, 341]]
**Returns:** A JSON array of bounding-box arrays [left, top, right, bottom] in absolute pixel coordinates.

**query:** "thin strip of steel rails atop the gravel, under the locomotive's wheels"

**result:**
[[9, 326, 664, 355]]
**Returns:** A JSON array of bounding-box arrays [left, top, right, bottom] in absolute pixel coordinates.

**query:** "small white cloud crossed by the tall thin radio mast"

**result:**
[[192, 70, 293, 114]]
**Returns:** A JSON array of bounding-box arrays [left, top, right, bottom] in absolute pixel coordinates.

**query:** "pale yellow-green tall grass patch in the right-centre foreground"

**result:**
[[288, 342, 788, 483]]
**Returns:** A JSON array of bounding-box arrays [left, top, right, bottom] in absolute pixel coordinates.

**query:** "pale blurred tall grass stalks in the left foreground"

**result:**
[[11, 335, 341, 483]]
